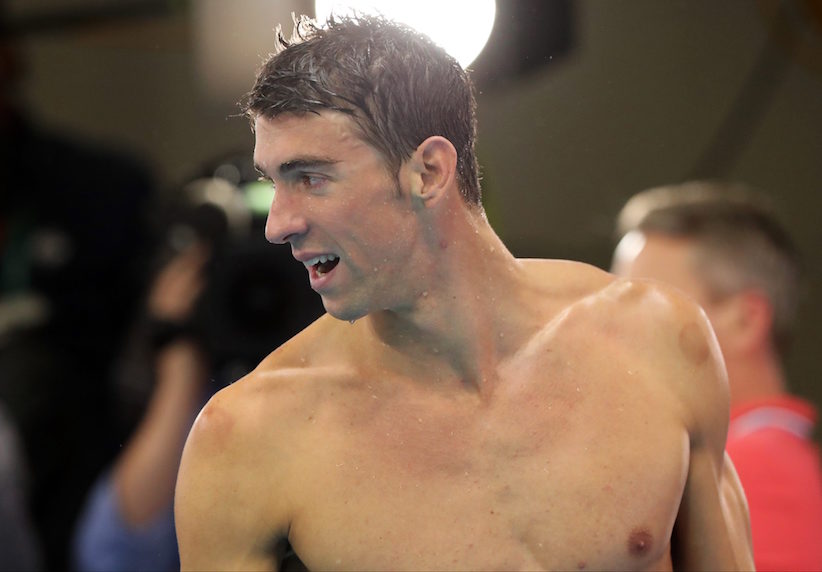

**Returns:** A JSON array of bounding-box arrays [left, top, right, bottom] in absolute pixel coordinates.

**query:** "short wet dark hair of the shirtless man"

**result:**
[[241, 15, 481, 207]]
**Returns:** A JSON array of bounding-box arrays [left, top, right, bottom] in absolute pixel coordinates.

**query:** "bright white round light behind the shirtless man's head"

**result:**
[[315, 0, 497, 68]]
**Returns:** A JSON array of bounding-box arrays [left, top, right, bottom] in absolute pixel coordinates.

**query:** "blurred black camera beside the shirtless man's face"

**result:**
[[159, 158, 324, 380]]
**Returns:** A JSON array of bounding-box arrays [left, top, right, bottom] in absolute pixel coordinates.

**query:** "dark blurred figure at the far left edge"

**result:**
[[0, 16, 153, 570]]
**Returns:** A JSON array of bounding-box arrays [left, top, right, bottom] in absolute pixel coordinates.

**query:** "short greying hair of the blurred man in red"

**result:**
[[617, 181, 802, 355]]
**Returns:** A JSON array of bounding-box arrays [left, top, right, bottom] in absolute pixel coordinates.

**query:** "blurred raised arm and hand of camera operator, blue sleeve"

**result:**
[[73, 244, 210, 572]]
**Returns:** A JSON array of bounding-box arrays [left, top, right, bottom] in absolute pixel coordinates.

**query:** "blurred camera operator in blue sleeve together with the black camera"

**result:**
[[73, 163, 322, 572]]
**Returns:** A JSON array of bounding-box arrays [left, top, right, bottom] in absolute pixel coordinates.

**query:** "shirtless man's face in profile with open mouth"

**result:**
[[254, 112, 418, 320]]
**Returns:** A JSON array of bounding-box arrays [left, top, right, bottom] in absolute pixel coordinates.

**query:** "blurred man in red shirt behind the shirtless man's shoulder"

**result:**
[[612, 181, 822, 570]]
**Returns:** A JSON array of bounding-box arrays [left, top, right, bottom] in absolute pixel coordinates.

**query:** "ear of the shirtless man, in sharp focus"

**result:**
[[403, 135, 457, 206]]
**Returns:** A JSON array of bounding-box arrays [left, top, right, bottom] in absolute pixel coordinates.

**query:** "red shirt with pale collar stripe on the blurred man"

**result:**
[[726, 396, 822, 570]]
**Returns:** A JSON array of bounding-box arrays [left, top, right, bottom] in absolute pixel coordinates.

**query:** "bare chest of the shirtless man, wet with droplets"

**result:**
[[290, 364, 688, 570]]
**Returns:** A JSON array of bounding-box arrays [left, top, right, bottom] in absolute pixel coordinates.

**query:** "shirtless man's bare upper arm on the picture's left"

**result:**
[[174, 384, 286, 570]]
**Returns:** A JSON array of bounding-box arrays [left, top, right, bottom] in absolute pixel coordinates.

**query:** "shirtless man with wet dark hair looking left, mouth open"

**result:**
[[176, 17, 751, 570]]
